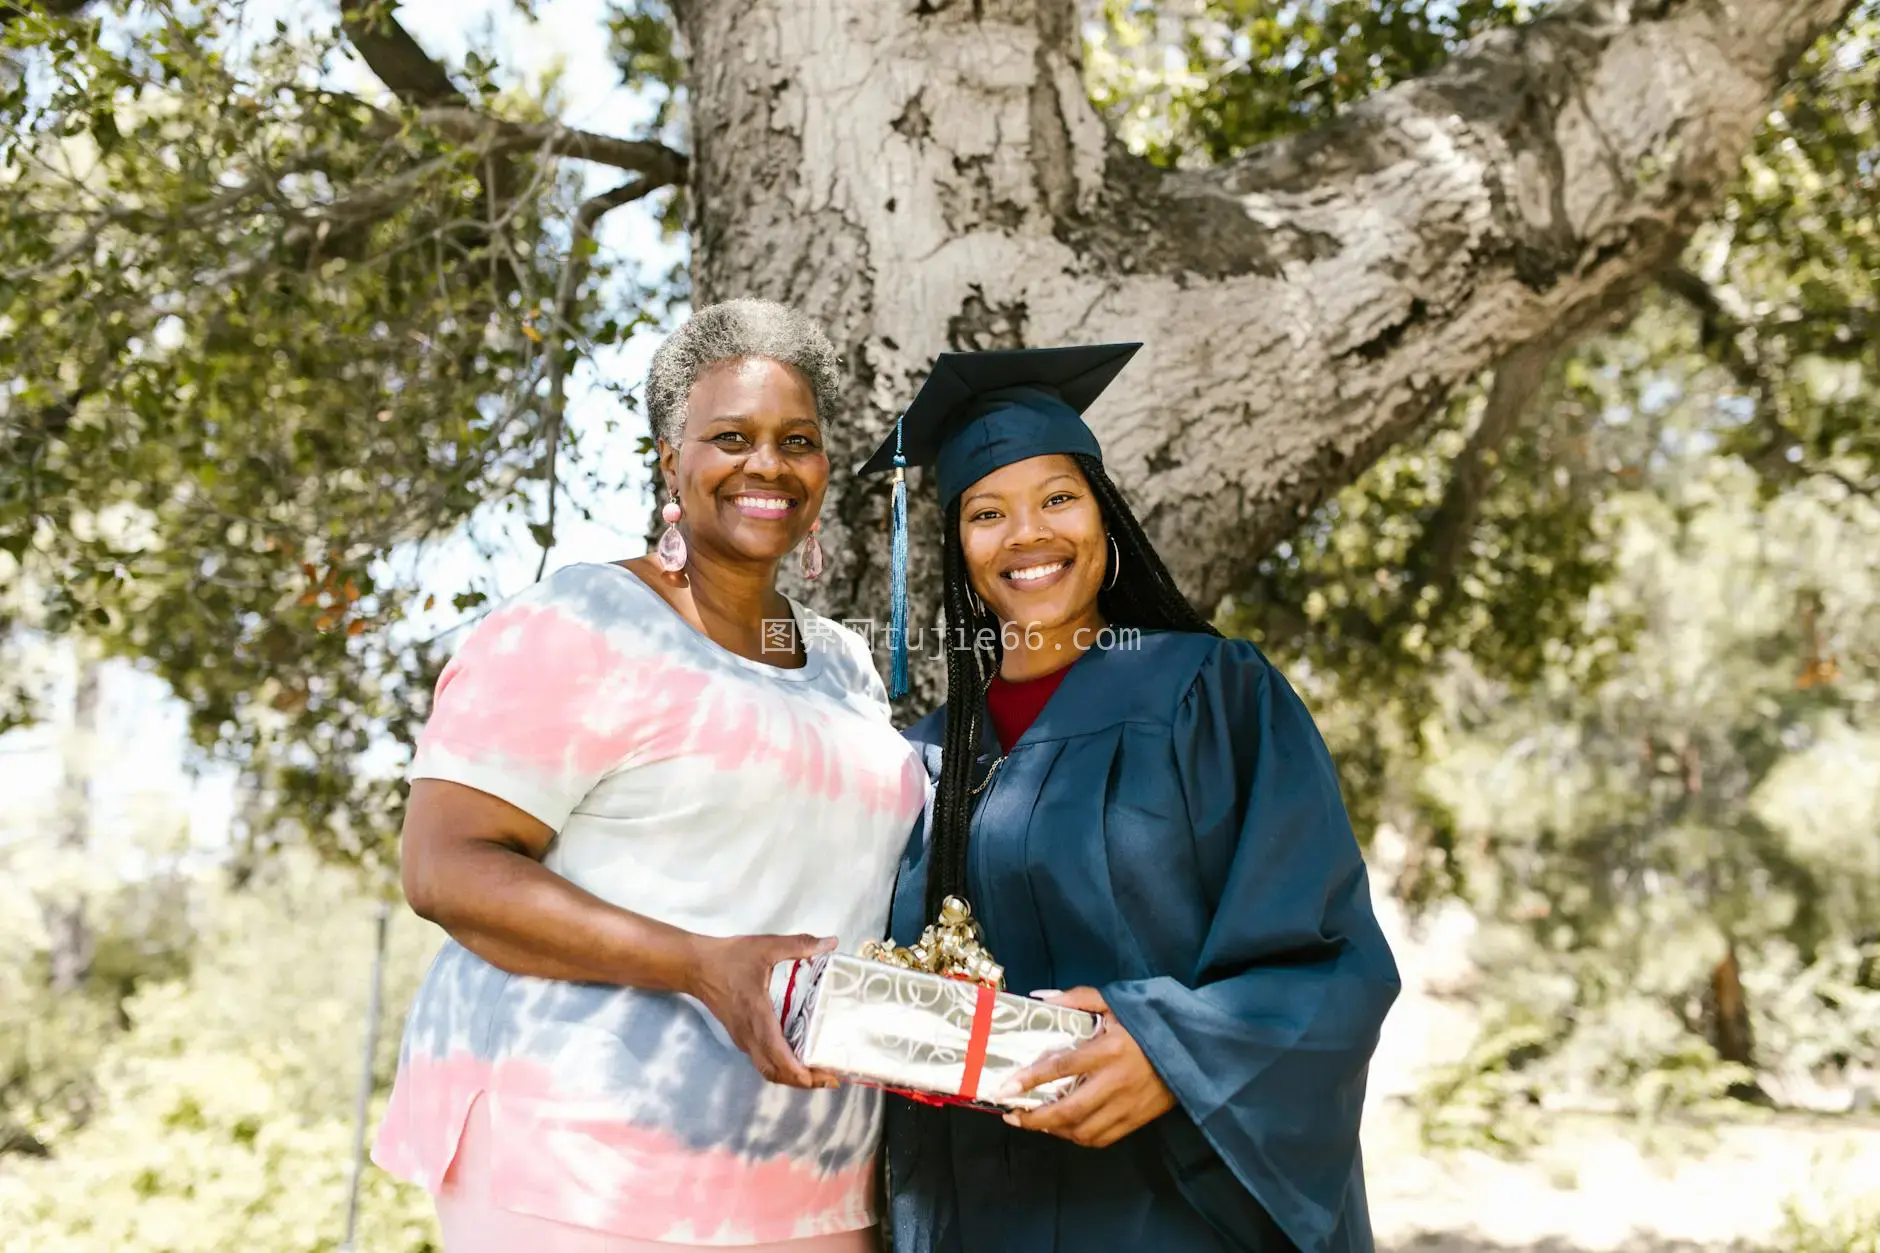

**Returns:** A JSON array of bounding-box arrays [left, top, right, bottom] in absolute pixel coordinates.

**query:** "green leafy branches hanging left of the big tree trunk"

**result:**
[[0, 0, 681, 856]]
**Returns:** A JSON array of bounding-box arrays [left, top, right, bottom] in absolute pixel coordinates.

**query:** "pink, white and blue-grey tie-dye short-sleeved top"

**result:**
[[372, 564, 927, 1245]]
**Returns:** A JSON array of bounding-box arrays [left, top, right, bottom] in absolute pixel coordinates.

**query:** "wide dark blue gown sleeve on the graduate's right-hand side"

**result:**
[[1102, 642, 1401, 1253]]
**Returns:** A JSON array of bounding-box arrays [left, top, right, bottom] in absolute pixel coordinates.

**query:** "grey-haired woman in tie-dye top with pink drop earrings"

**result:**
[[374, 301, 925, 1253]]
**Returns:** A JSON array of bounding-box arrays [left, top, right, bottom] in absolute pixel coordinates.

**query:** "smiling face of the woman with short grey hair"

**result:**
[[660, 357, 829, 563]]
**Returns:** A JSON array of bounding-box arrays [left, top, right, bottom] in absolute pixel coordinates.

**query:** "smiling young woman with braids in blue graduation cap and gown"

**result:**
[[867, 344, 1399, 1253]]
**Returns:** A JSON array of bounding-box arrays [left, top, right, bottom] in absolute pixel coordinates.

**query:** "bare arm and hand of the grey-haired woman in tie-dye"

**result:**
[[402, 779, 835, 1087]]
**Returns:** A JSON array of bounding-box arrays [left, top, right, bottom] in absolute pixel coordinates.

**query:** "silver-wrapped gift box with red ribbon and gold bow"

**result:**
[[782, 897, 1100, 1110]]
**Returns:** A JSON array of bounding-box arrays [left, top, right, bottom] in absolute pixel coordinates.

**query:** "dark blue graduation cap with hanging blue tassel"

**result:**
[[857, 344, 1141, 698]]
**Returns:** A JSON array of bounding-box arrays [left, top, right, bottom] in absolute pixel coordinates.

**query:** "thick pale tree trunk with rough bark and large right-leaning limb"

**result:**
[[679, 0, 1852, 703]]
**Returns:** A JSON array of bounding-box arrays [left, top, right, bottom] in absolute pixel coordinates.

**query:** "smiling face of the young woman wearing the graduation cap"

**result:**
[[959, 455, 1109, 632]]
